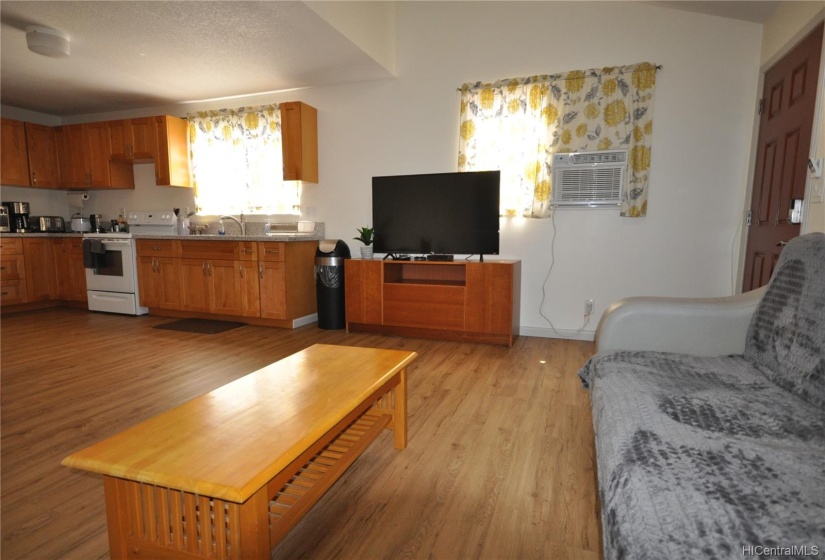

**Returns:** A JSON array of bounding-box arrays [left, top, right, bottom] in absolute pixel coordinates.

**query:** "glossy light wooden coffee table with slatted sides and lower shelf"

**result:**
[[63, 344, 417, 559]]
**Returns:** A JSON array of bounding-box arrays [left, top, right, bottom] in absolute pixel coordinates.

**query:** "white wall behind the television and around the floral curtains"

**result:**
[[0, 2, 761, 337]]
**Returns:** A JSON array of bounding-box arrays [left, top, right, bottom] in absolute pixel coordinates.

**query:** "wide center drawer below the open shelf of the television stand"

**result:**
[[384, 284, 464, 331]]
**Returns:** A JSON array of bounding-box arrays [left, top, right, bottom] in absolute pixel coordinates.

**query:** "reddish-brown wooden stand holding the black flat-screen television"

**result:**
[[344, 259, 521, 346]]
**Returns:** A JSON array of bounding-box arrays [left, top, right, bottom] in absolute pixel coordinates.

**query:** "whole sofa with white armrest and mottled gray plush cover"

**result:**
[[579, 233, 825, 560]]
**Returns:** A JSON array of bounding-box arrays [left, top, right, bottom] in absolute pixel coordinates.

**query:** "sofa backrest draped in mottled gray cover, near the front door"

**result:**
[[745, 233, 825, 409]]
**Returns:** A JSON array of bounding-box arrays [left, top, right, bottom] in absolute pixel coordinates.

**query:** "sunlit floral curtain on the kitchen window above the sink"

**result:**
[[187, 105, 300, 214]]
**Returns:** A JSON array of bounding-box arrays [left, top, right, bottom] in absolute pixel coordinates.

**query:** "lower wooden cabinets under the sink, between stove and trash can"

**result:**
[[137, 239, 317, 326]]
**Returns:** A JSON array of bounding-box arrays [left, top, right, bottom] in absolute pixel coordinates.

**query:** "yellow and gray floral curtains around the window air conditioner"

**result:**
[[458, 62, 656, 218]]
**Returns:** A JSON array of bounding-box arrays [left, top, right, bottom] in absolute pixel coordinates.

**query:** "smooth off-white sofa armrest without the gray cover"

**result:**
[[596, 287, 767, 356]]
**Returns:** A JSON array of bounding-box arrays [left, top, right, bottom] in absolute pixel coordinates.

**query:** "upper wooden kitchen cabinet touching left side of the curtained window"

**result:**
[[154, 115, 192, 188]]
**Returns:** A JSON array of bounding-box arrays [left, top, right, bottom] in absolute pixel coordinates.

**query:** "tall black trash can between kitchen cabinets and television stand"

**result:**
[[315, 239, 350, 330]]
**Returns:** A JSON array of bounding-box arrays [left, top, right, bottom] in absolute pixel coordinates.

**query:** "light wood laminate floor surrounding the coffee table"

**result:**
[[0, 309, 601, 560]]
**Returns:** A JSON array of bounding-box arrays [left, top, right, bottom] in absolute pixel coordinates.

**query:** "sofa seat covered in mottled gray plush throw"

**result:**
[[580, 352, 825, 560]]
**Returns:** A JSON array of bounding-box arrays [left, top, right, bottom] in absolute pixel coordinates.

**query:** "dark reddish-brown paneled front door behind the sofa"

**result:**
[[742, 24, 823, 291]]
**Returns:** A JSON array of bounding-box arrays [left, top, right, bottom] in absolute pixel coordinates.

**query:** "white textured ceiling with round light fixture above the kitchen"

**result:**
[[0, 0, 780, 117]]
